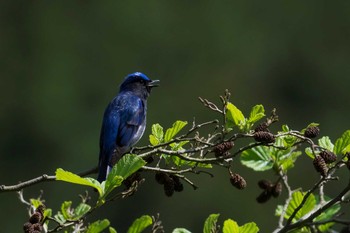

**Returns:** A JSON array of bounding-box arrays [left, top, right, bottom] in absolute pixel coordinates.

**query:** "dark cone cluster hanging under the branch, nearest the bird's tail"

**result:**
[[155, 172, 184, 197]]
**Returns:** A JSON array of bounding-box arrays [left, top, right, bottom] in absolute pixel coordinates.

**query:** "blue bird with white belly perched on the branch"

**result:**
[[97, 72, 159, 182]]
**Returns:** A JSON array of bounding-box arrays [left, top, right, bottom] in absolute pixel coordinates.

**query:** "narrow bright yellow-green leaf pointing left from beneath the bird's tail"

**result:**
[[56, 168, 103, 196]]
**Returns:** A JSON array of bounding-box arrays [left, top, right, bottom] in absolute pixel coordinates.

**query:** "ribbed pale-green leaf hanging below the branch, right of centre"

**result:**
[[241, 146, 273, 171]]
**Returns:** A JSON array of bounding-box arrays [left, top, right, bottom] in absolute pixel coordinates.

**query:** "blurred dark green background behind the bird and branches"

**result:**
[[0, 0, 350, 232]]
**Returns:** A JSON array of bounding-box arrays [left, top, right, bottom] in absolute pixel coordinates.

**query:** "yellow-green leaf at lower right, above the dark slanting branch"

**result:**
[[284, 191, 316, 222]]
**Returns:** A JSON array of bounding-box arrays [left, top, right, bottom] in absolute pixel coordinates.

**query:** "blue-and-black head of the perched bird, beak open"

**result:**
[[120, 72, 159, 97]]
